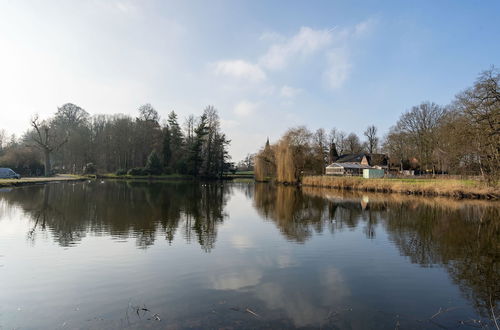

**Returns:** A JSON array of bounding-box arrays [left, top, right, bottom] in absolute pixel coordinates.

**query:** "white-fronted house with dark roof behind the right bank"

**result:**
[[325, 153, 389, 176]]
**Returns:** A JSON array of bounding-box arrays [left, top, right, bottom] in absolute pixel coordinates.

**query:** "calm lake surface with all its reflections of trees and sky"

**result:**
[[0, 181, 500, 329]]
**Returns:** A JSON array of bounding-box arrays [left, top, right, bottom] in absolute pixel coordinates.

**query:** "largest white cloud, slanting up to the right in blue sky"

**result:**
[[259, 27, 332, 70]]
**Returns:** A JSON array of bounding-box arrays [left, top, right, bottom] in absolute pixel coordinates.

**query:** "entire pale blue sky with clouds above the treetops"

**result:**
[[0, 0, 500, 161]]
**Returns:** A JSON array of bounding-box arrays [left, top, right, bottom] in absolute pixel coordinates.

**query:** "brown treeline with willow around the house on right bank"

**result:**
[[255, 68, 500, 183]]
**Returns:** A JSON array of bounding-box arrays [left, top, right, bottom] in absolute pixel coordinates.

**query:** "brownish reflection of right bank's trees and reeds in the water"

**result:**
[[254, 184, 500, 317]]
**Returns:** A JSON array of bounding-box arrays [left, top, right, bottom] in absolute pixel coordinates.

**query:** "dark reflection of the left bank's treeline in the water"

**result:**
[[0, 182, 229, 252]]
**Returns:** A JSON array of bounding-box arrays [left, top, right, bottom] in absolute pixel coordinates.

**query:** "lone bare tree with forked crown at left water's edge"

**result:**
[[29, 115, 68, 176]]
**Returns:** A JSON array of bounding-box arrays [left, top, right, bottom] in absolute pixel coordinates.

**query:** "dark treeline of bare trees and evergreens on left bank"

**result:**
[[0, 103, 230, 178]]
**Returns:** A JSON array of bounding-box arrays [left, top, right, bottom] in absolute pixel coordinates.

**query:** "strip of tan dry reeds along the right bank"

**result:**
[[302, 176, 500, 199]]
